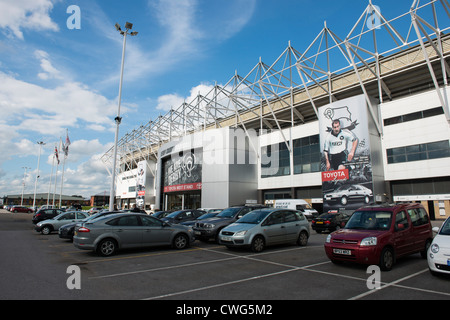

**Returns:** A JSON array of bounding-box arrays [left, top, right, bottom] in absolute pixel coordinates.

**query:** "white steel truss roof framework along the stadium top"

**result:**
[[102, 0, 450, 189]]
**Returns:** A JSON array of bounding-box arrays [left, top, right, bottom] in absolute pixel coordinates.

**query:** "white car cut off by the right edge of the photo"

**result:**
[[427, 218, 450, 275]]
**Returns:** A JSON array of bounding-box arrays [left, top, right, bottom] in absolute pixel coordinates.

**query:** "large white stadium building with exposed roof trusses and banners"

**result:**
[[102, 1, 450, 219]]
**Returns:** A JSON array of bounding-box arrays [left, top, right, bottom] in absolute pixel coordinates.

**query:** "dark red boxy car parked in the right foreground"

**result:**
[[325, 203, 433, 271]]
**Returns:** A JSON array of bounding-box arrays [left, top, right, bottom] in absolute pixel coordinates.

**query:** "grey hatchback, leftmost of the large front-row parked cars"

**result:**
[[73, 213, 195, 256]]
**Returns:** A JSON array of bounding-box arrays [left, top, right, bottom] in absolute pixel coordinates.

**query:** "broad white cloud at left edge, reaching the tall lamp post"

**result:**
[[0, 72, 119, 135]]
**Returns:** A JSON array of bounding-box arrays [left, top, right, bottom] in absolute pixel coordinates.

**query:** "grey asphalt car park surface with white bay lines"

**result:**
[[0, 209, 450, 304]]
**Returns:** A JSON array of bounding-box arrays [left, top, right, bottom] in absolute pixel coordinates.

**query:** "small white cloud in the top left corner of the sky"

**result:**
[[0, 0, 59, 39]]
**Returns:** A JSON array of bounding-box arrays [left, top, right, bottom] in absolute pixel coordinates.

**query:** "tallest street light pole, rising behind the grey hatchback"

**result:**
[[109, 22, 138, 211]]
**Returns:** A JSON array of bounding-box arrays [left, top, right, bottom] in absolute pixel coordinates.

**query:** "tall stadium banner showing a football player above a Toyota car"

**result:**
[[318, 95, 373, 212]]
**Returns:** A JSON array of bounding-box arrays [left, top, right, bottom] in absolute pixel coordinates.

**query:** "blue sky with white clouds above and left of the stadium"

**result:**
[[0, 0, 436, 197]]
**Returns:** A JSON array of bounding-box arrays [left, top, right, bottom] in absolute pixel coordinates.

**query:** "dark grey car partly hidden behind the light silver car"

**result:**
[[193, 205, 265, 242]]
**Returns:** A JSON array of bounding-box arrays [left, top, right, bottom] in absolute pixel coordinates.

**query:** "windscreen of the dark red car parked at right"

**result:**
[[345, 210, 392, 230]]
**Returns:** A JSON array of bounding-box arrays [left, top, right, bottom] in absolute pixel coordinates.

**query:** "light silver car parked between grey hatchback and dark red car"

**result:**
[[219, 208, 310, 252]]
